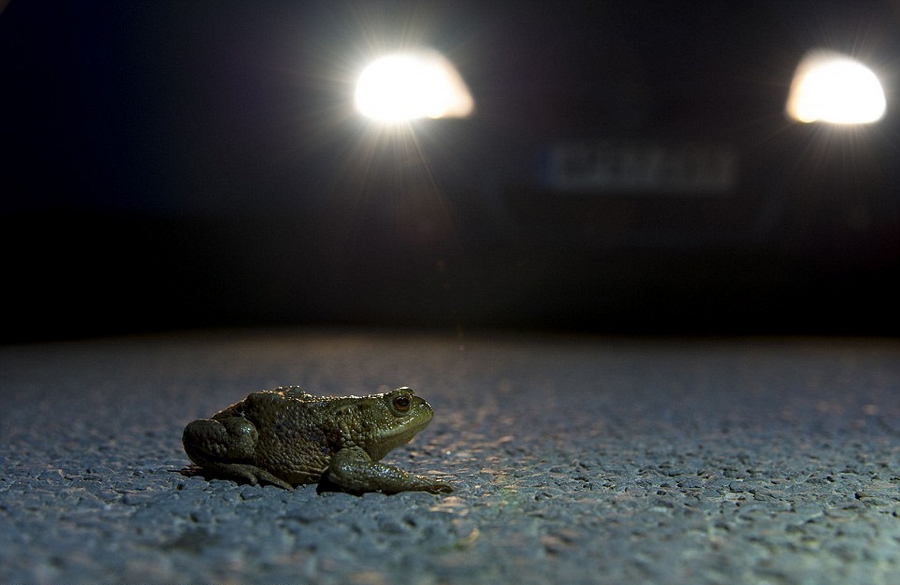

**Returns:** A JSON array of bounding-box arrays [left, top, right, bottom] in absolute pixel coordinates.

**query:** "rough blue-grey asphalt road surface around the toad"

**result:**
[[0, 331, 900, 585]]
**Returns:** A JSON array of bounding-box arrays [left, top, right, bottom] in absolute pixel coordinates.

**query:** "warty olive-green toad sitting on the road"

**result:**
[[182, 386, 452, 493]]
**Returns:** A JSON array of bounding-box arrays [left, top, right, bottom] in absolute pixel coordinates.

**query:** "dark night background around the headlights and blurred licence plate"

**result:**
[[0, 0, 900, 342]]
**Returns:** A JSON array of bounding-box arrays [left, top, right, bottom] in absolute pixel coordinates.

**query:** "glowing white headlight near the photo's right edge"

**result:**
[[787, 50, 886, 124]]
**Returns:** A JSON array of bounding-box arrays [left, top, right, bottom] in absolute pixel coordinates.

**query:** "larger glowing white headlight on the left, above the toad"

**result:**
[[354, 49, 475, 122]]
